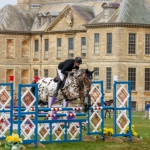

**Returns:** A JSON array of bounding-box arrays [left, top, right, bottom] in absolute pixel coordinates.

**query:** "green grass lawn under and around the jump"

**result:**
[[0, 112, 150, 150]]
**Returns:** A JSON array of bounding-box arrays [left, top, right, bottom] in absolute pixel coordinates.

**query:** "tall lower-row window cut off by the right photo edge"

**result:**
[[145, 68, 150, 91]]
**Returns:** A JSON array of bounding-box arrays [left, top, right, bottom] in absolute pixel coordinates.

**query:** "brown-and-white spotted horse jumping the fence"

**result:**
[[31, 69, 94, 112]]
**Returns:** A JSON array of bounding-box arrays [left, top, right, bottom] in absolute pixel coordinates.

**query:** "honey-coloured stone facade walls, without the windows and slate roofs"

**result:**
[[0, 0, 150, 111]]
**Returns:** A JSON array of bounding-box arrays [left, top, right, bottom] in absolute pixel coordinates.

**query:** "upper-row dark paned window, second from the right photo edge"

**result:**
[[128, 33, 136, 54]]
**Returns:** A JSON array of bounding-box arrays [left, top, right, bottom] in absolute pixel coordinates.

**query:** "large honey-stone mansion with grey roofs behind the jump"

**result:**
[[0, 0, 150, 111]]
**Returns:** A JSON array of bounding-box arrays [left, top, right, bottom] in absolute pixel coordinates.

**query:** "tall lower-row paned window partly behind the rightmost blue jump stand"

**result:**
[[128, 68, 136, 90]]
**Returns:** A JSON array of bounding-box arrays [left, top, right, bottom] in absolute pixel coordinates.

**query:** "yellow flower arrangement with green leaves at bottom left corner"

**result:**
[[5, 133, 22, 150]]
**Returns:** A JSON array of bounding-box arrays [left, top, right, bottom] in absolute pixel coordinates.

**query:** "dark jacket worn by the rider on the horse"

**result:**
[[58, 59, 79, 77]]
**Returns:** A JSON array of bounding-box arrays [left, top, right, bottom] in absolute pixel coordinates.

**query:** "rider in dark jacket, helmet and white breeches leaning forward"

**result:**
[[54, 57, 82, 97]]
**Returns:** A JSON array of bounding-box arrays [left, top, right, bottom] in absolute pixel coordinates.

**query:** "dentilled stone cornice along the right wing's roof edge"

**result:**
[[83, 22, 150, 28]]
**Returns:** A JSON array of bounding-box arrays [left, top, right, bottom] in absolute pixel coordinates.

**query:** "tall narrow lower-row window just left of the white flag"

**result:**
[[106, 68, 112, 90]]
